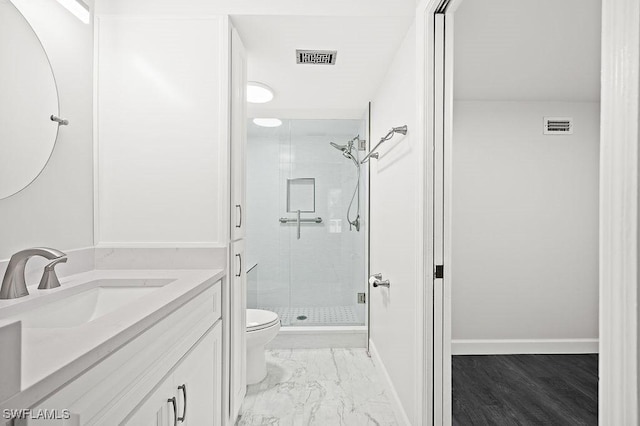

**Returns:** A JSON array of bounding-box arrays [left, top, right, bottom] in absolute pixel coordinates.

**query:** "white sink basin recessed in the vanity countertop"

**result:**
[[1, 280, 172, 329]]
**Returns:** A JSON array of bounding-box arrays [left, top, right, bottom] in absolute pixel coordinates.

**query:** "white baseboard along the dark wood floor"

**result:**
[[451, 339, 598, 355]]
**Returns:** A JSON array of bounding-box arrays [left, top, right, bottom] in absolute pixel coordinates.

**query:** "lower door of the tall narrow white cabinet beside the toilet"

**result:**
[[229, 240, 247, 424]]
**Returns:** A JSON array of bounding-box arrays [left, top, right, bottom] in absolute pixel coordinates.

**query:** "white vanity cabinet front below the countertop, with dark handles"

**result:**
[[21, 281, 224, 426]]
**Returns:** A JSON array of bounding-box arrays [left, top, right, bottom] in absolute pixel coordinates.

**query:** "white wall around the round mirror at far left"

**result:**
[[0, 0, 93, 259]]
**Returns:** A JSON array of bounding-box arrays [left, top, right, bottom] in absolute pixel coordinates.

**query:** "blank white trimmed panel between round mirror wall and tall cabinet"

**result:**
[[96, 12, 228, 246]]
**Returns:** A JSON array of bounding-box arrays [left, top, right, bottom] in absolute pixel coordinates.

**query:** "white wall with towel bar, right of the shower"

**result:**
[[370, 22, 424, 424]]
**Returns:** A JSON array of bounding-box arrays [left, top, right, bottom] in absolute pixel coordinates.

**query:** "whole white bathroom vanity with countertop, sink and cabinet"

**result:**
[[0, 270, 224, 426]]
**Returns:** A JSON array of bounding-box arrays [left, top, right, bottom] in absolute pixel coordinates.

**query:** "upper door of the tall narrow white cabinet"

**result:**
[[231, 28, 247, 241]]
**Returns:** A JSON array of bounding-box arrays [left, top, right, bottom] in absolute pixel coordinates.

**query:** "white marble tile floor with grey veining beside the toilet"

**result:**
[[236, 348, 398, 426]]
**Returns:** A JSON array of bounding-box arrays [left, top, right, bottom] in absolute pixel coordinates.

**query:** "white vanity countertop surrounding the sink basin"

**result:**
[[0, 269, 224, 410]]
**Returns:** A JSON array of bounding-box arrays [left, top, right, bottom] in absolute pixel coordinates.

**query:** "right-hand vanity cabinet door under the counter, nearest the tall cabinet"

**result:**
[[173, 321, 222, 426]]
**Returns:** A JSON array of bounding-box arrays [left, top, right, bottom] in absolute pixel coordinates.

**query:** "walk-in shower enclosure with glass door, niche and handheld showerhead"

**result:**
[[247, 120, 368, 327]]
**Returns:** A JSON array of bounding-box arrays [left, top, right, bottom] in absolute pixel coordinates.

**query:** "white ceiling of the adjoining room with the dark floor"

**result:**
[[454, 0, 601, 101]]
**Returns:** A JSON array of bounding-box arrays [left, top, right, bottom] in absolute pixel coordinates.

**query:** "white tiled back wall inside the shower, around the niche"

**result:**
[[247, 120, 366, 324]]
